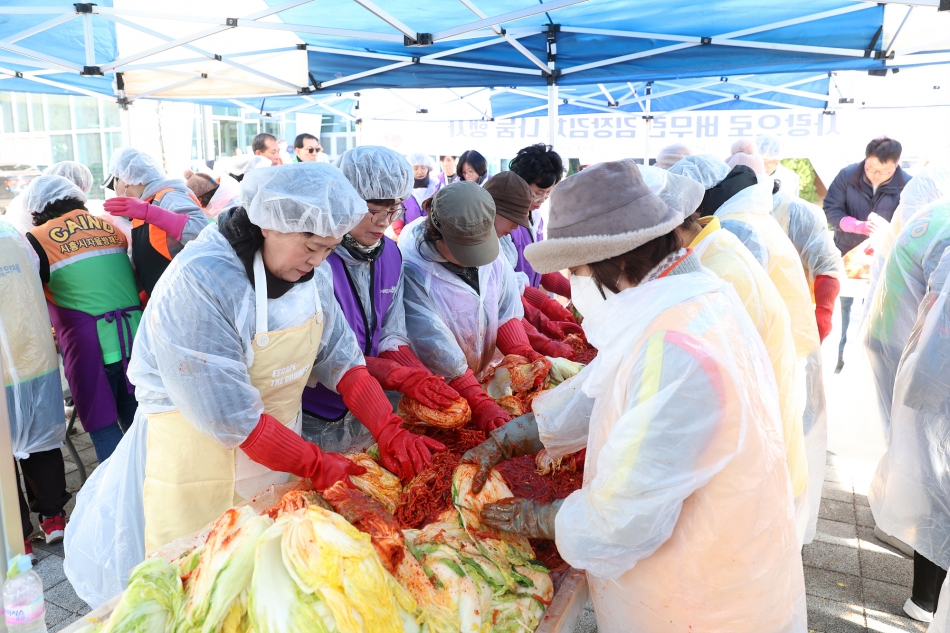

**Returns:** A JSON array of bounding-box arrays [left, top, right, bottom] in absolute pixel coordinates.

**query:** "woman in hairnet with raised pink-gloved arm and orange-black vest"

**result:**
[[103, 147, 208, 299]]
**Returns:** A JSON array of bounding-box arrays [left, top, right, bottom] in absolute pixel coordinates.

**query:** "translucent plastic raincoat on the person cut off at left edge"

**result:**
[[0, 220, 66, 459]]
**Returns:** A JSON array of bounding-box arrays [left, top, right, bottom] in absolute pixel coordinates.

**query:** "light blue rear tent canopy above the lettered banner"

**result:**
[[491, 73, 831, 119]]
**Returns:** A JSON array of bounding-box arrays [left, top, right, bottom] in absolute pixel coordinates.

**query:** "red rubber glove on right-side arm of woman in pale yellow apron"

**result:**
[[336, 365, 445, 480]]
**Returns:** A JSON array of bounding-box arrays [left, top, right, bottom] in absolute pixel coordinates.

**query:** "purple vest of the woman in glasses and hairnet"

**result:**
[[303, 237, 402, 421]]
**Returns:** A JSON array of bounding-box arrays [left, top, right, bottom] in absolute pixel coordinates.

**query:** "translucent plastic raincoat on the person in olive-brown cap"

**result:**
[[399, 218, 524, 380]]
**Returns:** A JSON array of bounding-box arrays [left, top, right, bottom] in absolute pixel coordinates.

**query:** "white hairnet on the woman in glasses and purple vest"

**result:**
[[335, 145, 413, 200]]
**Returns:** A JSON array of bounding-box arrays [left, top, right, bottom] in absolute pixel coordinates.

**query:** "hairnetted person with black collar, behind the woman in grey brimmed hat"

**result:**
[[670, 154, 827, 543]]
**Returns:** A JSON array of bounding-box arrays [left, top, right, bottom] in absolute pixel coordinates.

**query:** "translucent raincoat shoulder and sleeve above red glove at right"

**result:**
[[772, 190, 845, 289]]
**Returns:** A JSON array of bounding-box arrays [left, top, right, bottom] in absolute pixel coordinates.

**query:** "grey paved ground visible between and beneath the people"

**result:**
[[34, 288, 926, 633]]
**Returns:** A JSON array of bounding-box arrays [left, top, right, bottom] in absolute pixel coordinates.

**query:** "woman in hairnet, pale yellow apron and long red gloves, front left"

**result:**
[[65, 162, 416, 604]]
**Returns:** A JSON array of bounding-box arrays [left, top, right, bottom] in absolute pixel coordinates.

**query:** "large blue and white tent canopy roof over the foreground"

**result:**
[[0, 0, 950, 108]]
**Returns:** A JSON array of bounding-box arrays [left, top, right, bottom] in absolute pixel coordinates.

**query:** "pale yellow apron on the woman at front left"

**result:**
[[143, 253, 323, 555]]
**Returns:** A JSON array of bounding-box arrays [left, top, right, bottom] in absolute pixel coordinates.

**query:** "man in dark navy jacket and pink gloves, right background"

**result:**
[[825, 136, 910, 373]]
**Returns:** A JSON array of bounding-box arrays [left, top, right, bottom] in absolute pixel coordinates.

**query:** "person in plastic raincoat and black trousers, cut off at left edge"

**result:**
[[0, 220, 71, 558]]
